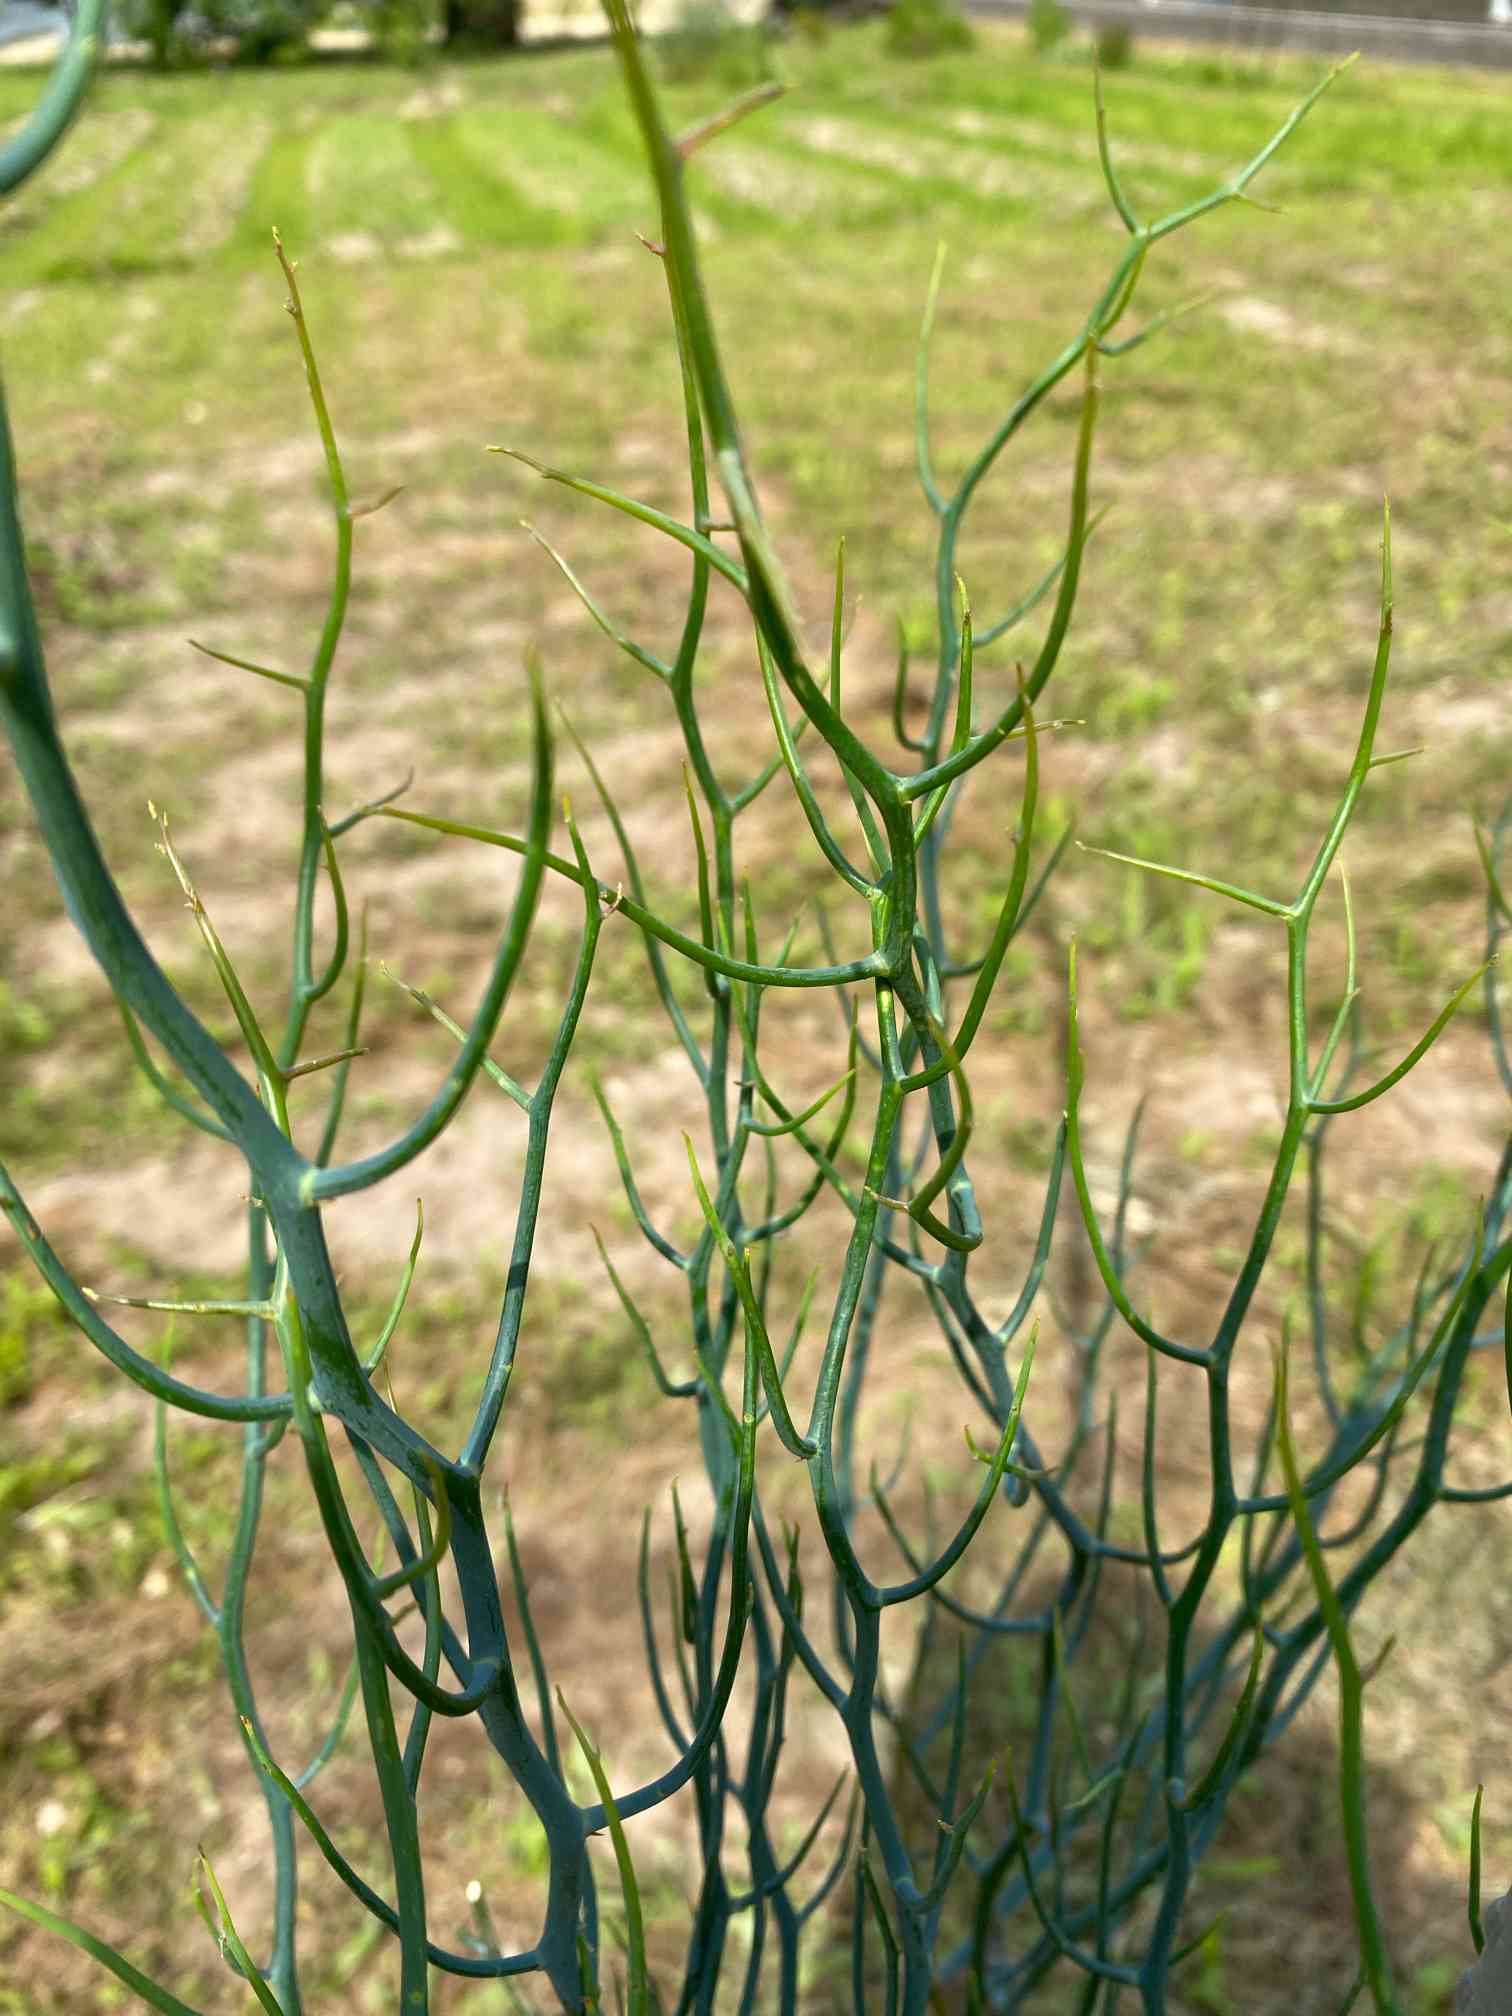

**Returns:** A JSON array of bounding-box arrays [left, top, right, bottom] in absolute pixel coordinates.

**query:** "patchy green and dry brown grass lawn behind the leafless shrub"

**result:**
[[0, 26, 1512, 2016]]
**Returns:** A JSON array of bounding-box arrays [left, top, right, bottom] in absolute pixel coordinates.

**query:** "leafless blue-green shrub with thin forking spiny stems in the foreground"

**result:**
[[0, 0, 1512, 2016]]
